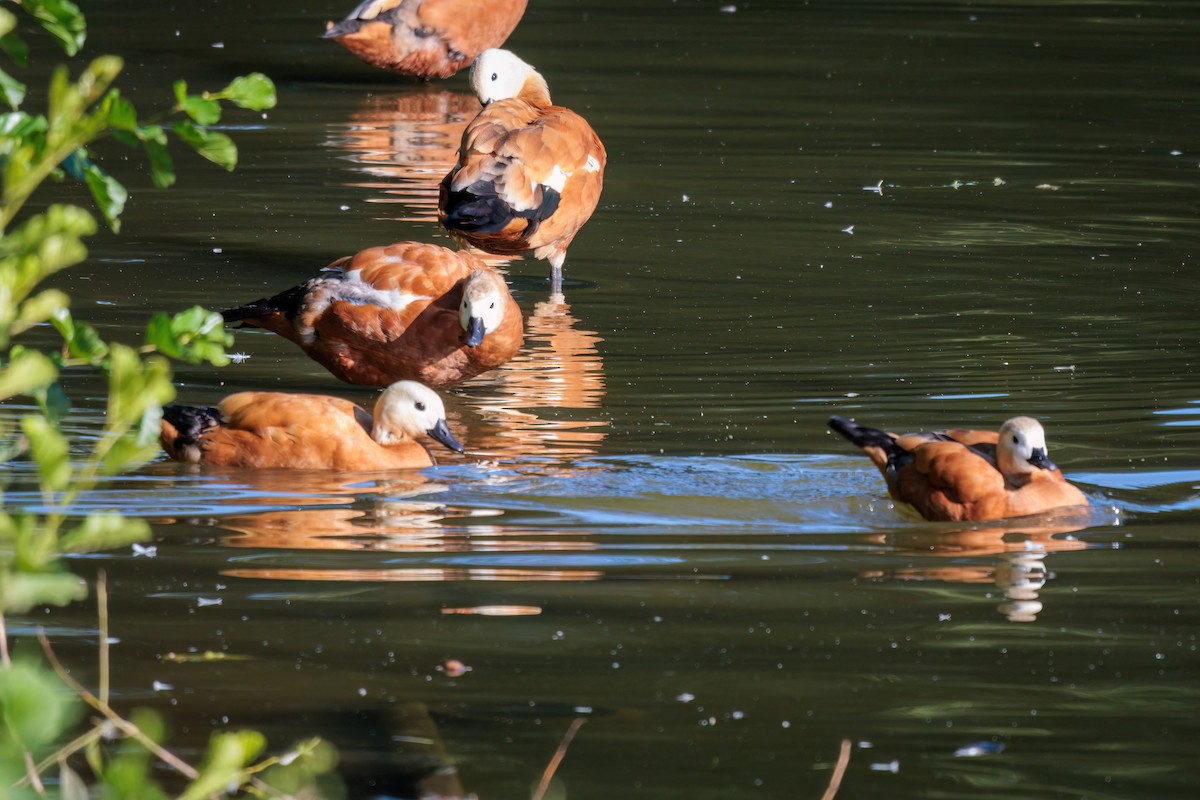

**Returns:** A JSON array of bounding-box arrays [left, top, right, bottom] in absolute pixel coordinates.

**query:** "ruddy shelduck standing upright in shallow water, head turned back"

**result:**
[[438, 49, 607, 294]]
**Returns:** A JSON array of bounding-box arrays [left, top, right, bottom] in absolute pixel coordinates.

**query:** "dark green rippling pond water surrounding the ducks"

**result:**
[[10, 0, 1200, 800]]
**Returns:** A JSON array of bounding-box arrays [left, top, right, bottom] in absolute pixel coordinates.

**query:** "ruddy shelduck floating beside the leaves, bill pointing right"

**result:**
[[162, 380, 462, 470]]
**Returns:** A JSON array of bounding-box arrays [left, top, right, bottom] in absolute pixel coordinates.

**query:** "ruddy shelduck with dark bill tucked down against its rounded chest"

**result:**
[[221, 242, 524, 389]]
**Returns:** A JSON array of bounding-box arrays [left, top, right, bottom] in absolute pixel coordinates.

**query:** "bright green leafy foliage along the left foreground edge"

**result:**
[[0, 0, 332, 800]]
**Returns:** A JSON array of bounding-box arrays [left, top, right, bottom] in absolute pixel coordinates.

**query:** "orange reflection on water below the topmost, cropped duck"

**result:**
[[328, 86, 479, 223]]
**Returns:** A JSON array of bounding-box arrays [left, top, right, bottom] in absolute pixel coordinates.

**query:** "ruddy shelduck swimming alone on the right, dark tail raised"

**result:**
[[829, 416, 1088, 522]]
